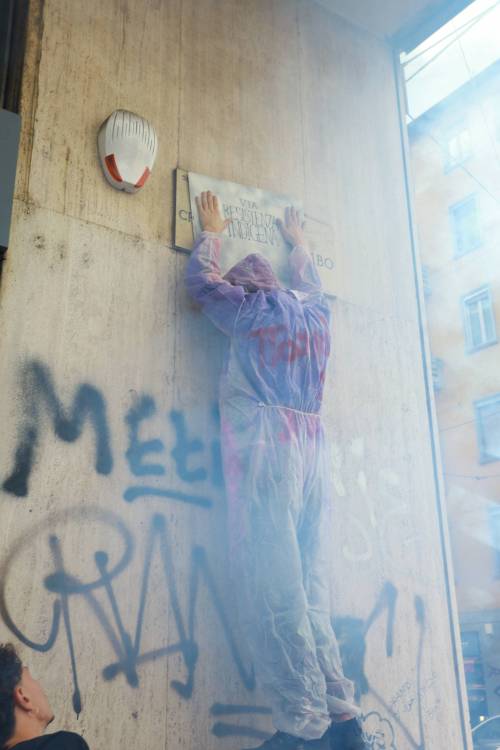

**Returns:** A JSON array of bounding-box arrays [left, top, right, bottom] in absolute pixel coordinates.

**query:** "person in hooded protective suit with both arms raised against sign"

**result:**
[[185, 191, 367, 750]]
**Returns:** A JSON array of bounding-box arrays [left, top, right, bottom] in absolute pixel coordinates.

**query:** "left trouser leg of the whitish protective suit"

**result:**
[[233, 440, 330, 739]]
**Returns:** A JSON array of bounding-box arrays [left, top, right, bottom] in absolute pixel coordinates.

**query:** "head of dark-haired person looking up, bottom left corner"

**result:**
[[0, 643, 54, 750]]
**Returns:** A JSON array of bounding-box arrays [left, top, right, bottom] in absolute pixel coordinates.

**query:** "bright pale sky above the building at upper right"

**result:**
[[401, 0, 500, 119]]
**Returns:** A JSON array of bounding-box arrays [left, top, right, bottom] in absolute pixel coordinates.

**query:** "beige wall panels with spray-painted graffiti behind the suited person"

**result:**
[[0, 0, 465, 750]]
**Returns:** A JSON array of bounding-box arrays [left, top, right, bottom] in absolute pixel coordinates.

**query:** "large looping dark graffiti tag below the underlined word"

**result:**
[[0, 508, 255, 713]]
